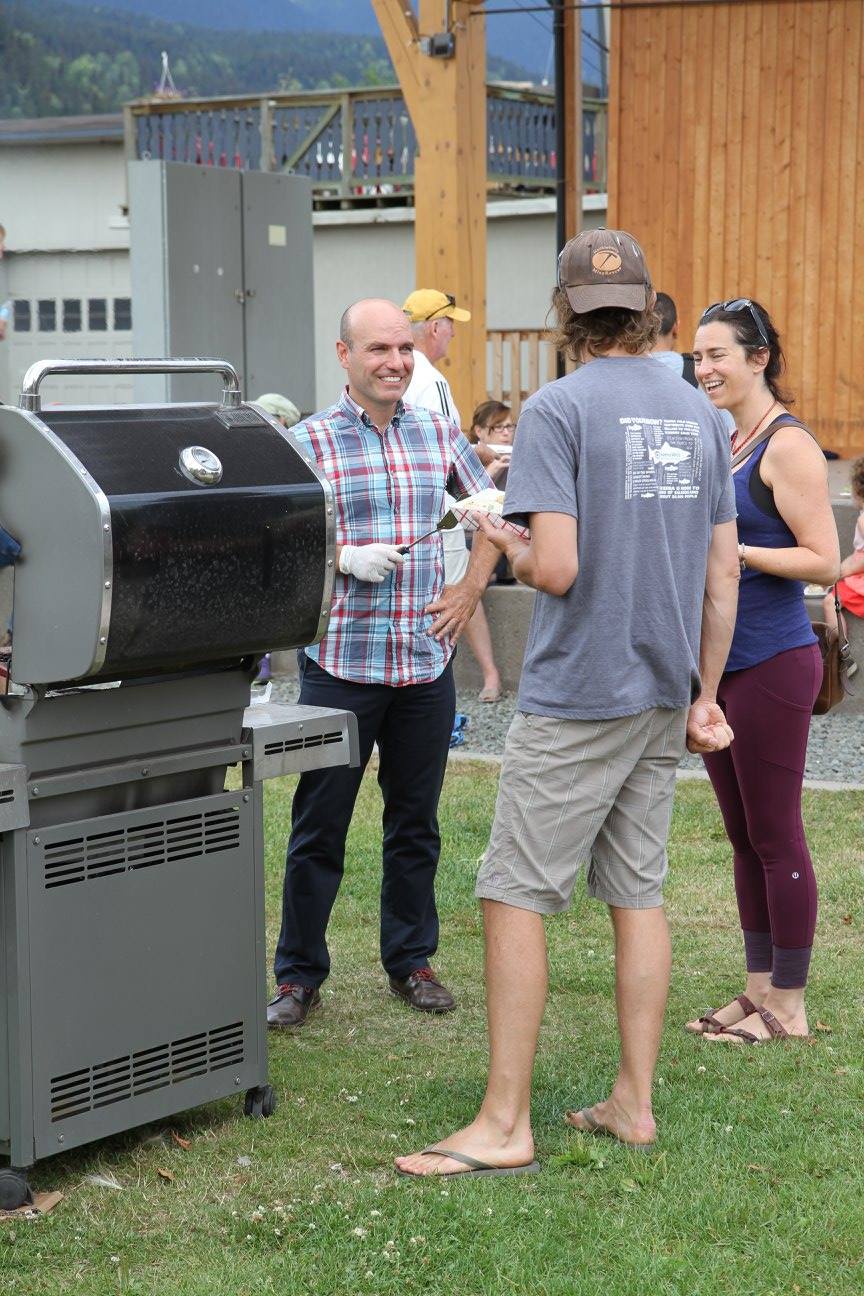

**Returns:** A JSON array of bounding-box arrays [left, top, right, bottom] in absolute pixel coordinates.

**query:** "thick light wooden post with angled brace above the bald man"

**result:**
[[372, 0, 486, 422]]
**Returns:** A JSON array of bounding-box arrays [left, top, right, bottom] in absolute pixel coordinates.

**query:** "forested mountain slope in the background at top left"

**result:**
[[0, 0, 536, 117]]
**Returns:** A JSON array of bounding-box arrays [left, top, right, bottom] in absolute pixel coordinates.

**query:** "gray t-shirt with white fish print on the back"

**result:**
[[504, 355, 736, 719]]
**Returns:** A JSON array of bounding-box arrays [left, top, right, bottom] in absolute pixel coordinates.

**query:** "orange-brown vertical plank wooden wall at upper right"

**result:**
[[608, 0, 864, 457]]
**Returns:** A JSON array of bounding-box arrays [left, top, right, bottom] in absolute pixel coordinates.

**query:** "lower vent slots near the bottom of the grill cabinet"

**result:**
[[51, 1021, 245, 1121]]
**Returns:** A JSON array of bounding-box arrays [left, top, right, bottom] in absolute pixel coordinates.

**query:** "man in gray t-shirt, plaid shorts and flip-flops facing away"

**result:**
[[396, 229, 738, 1174]]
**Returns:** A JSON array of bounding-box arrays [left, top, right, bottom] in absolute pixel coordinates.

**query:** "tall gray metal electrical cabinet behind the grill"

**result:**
[[128, 161, 315, 413]]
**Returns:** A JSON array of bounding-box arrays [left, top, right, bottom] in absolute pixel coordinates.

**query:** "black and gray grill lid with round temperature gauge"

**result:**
[[0, 362, 334, 684]]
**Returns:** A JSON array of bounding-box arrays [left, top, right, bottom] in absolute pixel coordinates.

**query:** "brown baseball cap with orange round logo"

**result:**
[[558, 229, 652, 315]]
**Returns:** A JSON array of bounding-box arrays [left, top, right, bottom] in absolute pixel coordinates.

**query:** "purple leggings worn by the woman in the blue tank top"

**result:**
[[705, 644, 823, 989]]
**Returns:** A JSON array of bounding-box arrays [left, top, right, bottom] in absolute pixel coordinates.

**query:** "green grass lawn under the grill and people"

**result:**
[[0, 763, 864, 1296]]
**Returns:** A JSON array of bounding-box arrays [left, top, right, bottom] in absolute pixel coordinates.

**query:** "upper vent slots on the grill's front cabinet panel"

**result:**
[[44, 806, 240, 890]]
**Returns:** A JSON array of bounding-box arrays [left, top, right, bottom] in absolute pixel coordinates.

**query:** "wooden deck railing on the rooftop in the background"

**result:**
[[124, 84, 606, 203]]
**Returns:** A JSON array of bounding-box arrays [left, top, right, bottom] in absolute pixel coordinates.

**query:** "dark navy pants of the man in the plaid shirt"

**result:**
[[275, 653, 456, 986]]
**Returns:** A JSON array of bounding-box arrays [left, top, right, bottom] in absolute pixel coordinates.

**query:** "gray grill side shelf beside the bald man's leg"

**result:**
[[244, 702, 360, 781]]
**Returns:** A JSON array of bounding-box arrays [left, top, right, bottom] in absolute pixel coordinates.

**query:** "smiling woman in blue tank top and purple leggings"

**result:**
[[688, 298, 839, 1045]]
